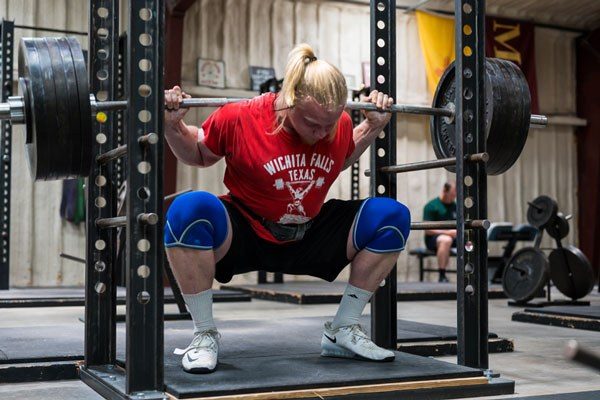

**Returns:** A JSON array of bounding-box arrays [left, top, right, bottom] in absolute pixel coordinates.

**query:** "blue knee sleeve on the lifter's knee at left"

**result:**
[[164, 192, 227, 250]]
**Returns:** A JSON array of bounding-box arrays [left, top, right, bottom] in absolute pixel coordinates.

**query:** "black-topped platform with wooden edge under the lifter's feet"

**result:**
[[105, 318, 514, 400]]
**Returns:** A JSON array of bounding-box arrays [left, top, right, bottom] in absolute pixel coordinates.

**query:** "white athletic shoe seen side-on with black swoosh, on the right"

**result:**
[[321, 322, 396, 361]]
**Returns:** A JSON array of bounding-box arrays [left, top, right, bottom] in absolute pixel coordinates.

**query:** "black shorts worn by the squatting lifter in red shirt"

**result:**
[[215, 200, 363, 283]]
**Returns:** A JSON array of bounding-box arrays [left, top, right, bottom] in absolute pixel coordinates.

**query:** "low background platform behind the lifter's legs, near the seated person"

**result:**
[[221, 281, 506, 304]]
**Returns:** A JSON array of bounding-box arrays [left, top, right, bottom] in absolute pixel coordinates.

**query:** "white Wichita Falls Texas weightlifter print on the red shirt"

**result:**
[[263, 153, 334, 224]]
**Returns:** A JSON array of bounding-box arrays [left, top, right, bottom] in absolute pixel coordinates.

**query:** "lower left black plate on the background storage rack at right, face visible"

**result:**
[[502, 247, 548, 302]]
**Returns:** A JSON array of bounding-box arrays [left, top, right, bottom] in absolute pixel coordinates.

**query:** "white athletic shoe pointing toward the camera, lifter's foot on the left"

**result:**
[[173, 329, 221, 374]]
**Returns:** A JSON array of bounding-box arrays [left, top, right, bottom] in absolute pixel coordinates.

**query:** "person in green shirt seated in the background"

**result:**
[[423, 182, 456, 282]]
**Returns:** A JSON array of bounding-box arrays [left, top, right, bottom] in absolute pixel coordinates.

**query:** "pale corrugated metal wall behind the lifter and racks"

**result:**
[[0, 0, 577, 286]]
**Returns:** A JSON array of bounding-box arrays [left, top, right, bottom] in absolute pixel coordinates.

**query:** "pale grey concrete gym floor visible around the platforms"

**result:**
[[0, 288, 600, 400]]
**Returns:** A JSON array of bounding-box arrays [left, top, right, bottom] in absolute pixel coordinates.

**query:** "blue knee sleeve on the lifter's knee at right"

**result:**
[[352, 197, 410, 253]]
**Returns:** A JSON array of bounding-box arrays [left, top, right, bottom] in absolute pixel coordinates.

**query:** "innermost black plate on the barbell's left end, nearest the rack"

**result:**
[[67, 37, 93, 177]]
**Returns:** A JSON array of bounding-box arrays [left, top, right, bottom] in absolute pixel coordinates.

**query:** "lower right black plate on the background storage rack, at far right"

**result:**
[[549, 246, 595, 300]]
